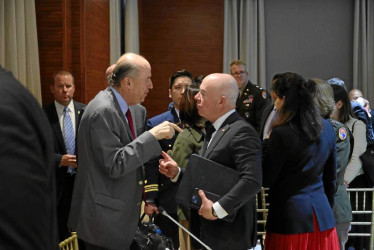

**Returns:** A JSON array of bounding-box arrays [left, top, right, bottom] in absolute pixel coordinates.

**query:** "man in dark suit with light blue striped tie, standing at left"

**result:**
[[44, 71, 85, 241]]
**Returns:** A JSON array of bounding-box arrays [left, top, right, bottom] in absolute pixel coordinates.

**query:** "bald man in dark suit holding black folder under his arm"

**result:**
[[160, 74, 262, 250]]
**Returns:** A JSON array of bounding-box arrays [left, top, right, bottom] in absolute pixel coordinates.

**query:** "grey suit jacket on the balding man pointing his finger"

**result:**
[[69, 88, 161, 250]]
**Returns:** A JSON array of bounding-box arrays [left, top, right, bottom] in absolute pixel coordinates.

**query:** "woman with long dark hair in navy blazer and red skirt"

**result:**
[[263, 73, 339, 250]]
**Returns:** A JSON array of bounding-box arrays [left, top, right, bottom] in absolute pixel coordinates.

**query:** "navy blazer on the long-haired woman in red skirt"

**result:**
[[263, 120, 336, 234]]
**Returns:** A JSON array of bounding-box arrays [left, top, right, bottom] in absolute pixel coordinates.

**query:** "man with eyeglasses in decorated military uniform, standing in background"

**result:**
[[230, 60, 272, 133]]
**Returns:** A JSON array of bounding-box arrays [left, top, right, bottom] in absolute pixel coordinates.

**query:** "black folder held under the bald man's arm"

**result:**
[[175, 154, 239, 222]]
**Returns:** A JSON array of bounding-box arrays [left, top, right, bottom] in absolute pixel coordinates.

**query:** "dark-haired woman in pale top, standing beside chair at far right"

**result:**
[[331, 84, 372, 249]]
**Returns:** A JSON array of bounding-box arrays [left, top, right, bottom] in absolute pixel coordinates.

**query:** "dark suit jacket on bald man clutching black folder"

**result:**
[[200, 112, 262, 250]]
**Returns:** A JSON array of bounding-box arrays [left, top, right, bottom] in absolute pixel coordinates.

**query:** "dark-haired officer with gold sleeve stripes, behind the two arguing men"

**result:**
[[144, 70, 193, 249]]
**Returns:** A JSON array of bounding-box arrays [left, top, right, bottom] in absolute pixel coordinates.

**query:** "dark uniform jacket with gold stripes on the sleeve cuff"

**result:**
[[144, 106, 179, 214]]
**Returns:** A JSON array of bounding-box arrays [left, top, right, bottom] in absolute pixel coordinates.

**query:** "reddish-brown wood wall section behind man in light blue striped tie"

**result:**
[[35, 0, 110, 105]]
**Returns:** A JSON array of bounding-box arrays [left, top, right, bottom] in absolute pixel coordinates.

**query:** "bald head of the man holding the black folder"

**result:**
[[195, 73, 239, 122]]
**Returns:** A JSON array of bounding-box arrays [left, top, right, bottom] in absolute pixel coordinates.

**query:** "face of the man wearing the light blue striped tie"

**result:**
[[50, 75, 75, 106]]
